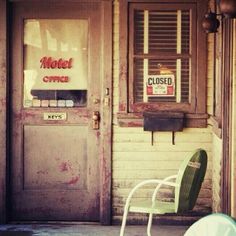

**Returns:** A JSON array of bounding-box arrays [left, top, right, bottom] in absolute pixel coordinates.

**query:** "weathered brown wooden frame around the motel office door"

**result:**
[[0, 0, 112, 225]]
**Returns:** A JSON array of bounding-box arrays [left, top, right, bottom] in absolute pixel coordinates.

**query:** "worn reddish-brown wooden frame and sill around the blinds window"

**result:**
[[118, 0, 208, 127]]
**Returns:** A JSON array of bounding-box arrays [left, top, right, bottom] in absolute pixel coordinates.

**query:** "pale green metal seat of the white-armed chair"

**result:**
[[129, 200, 175, 214]]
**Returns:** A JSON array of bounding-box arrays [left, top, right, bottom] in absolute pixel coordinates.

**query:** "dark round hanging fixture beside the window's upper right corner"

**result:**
[[202, 11, 220, 33]]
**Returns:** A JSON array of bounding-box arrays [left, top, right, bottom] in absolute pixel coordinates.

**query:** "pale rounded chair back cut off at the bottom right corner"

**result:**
[[184, 213, 236, 236]]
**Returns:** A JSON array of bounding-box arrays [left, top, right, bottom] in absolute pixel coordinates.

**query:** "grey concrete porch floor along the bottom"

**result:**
[[0, 224, 188, 236]]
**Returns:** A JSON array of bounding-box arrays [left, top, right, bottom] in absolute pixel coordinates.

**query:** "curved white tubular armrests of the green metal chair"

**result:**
[[125, 176, 178, 209]]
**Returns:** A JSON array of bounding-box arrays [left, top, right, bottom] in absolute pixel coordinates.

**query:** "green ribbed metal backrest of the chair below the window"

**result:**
[[175, 149, 207, 213]]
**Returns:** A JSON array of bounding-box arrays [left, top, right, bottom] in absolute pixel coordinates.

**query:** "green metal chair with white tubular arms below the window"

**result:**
[[120, 149, 207, 236]]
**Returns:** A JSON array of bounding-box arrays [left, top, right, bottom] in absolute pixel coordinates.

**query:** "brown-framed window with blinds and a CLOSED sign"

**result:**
[[119, 0, 207, 127]]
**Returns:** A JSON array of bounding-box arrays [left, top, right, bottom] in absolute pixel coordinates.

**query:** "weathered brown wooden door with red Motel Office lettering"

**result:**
[[10, 1, 105, 221]]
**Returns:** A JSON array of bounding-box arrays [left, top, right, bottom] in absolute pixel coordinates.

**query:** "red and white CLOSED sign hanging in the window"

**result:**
[[146, 74, 175, 97]]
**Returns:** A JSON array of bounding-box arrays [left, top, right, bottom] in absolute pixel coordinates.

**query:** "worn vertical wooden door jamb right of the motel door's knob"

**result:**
[[100, 1, 113, 225]]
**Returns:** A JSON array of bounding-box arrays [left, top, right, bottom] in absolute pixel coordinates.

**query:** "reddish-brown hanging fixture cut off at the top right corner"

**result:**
[[218, 0, 236, 18]]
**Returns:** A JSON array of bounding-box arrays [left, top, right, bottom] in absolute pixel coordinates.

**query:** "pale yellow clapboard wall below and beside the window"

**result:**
[[112, 0, 213, 222]]
